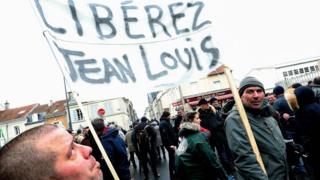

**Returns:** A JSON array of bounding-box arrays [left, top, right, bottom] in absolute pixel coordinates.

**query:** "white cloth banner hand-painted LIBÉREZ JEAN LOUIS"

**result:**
[[32, 0, 219, 99]]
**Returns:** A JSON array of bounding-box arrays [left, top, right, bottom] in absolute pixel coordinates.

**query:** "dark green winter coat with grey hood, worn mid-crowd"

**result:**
[[175, 122, 226, 180]]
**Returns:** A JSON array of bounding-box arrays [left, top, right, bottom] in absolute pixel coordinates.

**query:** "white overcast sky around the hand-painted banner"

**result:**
[[0, 0, 320, 115]]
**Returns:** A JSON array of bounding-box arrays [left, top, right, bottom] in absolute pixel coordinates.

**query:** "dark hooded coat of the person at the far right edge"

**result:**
[[294, 87, 320, 178]]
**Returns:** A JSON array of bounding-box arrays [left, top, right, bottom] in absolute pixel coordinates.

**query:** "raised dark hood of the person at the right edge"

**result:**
[[294, 86, 316, 108]]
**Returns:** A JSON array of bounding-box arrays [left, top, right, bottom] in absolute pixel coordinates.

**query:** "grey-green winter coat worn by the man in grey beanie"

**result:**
[[225, 102, 288, 180]]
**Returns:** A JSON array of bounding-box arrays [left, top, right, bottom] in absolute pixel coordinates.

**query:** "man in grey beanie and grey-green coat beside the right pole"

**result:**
[[225, 77, 288, 180]]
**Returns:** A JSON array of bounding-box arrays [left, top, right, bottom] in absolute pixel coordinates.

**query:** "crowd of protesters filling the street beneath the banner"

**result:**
[[0, 77, 320, 180]]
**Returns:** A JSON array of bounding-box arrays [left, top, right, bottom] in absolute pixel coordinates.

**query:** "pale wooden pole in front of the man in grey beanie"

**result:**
[[224, 67, 267, 175]]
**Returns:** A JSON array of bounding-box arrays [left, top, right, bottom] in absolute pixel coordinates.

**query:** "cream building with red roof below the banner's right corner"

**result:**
[[145, 66, 233, 119]]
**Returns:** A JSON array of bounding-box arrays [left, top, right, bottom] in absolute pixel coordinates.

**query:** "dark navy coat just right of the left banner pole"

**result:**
[[101, 128, 131, 180]]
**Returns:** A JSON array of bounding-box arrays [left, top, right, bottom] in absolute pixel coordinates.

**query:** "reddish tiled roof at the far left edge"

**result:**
[[0, 104, 39, 122]]
